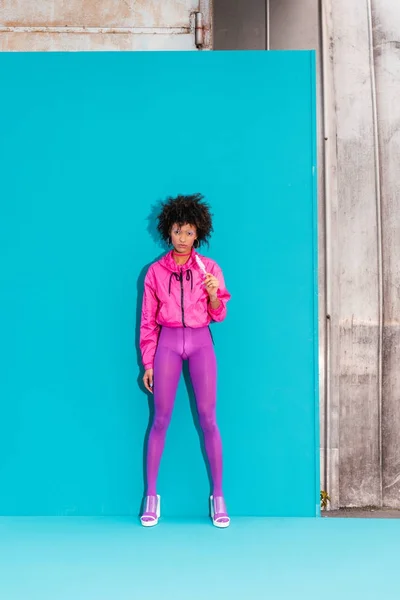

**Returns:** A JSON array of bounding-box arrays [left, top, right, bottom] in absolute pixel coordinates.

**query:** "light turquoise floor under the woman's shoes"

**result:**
[[0, 517, 400, 600]]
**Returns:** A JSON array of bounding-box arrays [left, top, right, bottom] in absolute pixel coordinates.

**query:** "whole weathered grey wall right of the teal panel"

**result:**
[[270, 0, 400, 508]]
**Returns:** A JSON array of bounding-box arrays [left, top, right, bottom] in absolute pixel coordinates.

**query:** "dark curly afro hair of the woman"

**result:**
[[157, 194, 213, 248]]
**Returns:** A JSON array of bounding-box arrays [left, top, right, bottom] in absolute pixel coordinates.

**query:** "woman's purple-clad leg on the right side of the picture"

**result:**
[[189, 338, 223, 496]]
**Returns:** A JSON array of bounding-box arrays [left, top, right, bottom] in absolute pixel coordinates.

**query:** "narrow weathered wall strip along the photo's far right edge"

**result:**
[[373, 0, 400, 508]]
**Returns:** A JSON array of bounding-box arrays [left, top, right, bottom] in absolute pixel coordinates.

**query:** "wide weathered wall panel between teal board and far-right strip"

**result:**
[[331, 0, 381, 506]]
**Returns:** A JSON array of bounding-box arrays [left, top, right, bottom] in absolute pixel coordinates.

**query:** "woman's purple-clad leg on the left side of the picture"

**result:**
[[147, 344, 182, 496]]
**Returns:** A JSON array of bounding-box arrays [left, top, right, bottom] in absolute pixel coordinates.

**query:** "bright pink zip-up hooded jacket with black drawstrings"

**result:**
[[140, 250, 231, 369]]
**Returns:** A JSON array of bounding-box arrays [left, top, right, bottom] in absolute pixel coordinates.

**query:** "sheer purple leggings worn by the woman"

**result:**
[[147, 327, 223, 496]]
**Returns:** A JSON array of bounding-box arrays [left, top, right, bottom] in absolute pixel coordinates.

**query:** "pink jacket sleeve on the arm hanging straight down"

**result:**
[[139, 267, 160, 369]]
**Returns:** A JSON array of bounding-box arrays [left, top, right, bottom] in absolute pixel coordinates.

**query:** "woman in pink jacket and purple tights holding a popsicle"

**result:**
[[140, 194, 230, 527]]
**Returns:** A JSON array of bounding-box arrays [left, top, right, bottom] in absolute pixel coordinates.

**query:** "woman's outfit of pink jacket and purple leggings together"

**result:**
[[140, 250, 230, 498]]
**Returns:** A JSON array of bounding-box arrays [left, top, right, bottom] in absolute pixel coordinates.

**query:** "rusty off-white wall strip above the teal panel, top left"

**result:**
[[0, 0, 211, 51]]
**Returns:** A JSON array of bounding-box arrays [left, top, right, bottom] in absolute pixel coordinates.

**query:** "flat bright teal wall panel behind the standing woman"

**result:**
[[0, 52, 319, 516]]
